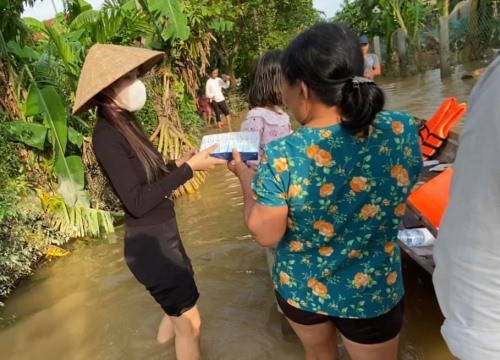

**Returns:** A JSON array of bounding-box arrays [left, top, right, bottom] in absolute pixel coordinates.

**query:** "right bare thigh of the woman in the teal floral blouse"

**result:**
[[342, 335, 399, 360]]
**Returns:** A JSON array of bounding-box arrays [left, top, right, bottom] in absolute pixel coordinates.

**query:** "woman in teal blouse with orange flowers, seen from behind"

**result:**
[[229, 24, 422, 360]]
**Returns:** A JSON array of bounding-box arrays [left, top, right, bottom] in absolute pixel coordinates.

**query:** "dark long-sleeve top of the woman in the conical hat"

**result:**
[[92, 119, 193, 226]]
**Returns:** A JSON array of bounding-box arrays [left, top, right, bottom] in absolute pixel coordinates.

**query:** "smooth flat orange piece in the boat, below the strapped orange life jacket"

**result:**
[[408, 168, 453, 229]]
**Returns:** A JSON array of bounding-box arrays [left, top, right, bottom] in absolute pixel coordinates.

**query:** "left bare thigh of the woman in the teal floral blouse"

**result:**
[[287, 318, 338, 360]]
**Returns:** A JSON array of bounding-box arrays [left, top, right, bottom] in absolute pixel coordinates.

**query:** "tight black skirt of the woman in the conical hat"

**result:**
[[125, 218, 199, 316]]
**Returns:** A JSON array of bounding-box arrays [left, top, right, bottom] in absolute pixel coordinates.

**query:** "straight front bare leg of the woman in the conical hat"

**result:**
[[170, 305, 201, 360]]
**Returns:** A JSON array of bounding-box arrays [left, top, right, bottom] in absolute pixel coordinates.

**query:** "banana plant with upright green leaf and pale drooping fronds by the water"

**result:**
[[9, 79, 113, 236]]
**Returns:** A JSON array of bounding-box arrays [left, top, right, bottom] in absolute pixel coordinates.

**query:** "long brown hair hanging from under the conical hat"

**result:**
[[94, 92, 168, 184]]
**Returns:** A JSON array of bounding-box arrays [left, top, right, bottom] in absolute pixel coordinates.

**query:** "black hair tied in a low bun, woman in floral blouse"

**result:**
[[281, 23, 385, 132]]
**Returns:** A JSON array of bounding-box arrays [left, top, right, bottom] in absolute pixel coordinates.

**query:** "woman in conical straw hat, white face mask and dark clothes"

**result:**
[[73, 44, 225, 360]]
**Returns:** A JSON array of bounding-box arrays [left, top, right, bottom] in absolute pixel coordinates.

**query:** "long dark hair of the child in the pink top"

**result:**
[[248, 50, 283, 108]]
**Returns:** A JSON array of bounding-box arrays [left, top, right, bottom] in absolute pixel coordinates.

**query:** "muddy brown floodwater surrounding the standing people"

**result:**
[[0, 65, 484, 360]]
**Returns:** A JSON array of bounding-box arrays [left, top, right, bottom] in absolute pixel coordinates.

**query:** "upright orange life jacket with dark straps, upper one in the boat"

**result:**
[[419, 98, 467, 160]]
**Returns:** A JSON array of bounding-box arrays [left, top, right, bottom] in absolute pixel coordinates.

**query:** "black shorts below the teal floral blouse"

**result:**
[[276, 292, 404, 345]]
